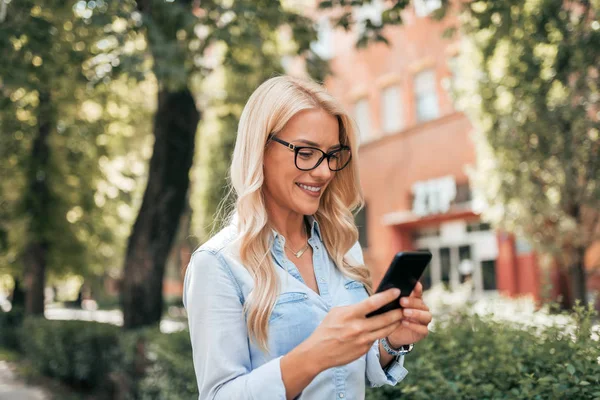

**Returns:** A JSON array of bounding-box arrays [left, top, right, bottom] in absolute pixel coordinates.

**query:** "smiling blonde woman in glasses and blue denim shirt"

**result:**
[[183, 76, 431, 400]]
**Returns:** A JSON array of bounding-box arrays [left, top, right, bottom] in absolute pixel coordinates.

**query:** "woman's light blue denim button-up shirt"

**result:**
[[183, 217, 407, 400]]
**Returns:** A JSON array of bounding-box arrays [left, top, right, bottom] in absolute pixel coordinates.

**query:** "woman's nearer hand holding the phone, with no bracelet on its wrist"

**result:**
[[303, 289, 403, 371]]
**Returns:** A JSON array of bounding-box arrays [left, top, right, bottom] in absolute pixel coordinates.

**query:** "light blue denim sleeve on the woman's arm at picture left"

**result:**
[[183, 250, 286, 400]]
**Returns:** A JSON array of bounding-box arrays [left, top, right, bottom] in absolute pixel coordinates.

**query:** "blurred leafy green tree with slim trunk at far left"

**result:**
[[0, 0, 148, 314]]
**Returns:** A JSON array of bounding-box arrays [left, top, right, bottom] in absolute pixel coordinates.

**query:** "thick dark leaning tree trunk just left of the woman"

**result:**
[[121, 87, 200, 329]]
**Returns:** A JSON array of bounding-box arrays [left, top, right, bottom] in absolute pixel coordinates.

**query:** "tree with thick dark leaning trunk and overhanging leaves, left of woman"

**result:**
[[121, 0, 322, 329]]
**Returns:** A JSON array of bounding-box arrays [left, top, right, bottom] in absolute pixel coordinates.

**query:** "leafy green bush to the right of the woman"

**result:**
[[367, 308, 600, 400]]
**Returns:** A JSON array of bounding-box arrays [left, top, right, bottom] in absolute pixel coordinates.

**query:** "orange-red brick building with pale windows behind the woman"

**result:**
[[315, 0, 600, 299]]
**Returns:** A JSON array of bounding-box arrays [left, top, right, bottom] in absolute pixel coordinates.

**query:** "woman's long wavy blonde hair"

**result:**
[[228, 76, 372, 351]]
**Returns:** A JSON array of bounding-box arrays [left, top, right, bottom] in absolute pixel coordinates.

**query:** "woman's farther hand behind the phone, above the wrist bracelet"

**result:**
[[388, 282, 432, 349]]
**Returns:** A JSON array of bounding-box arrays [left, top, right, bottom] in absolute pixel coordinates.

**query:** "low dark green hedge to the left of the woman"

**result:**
[[7, 314, 197, 399]]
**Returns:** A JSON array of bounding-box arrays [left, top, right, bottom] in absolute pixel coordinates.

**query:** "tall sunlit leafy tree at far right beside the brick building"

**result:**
[[460, 0, 600, 302]]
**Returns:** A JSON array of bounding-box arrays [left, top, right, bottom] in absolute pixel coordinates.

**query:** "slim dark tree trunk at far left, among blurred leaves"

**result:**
[[23, 90, 52, 315]]
